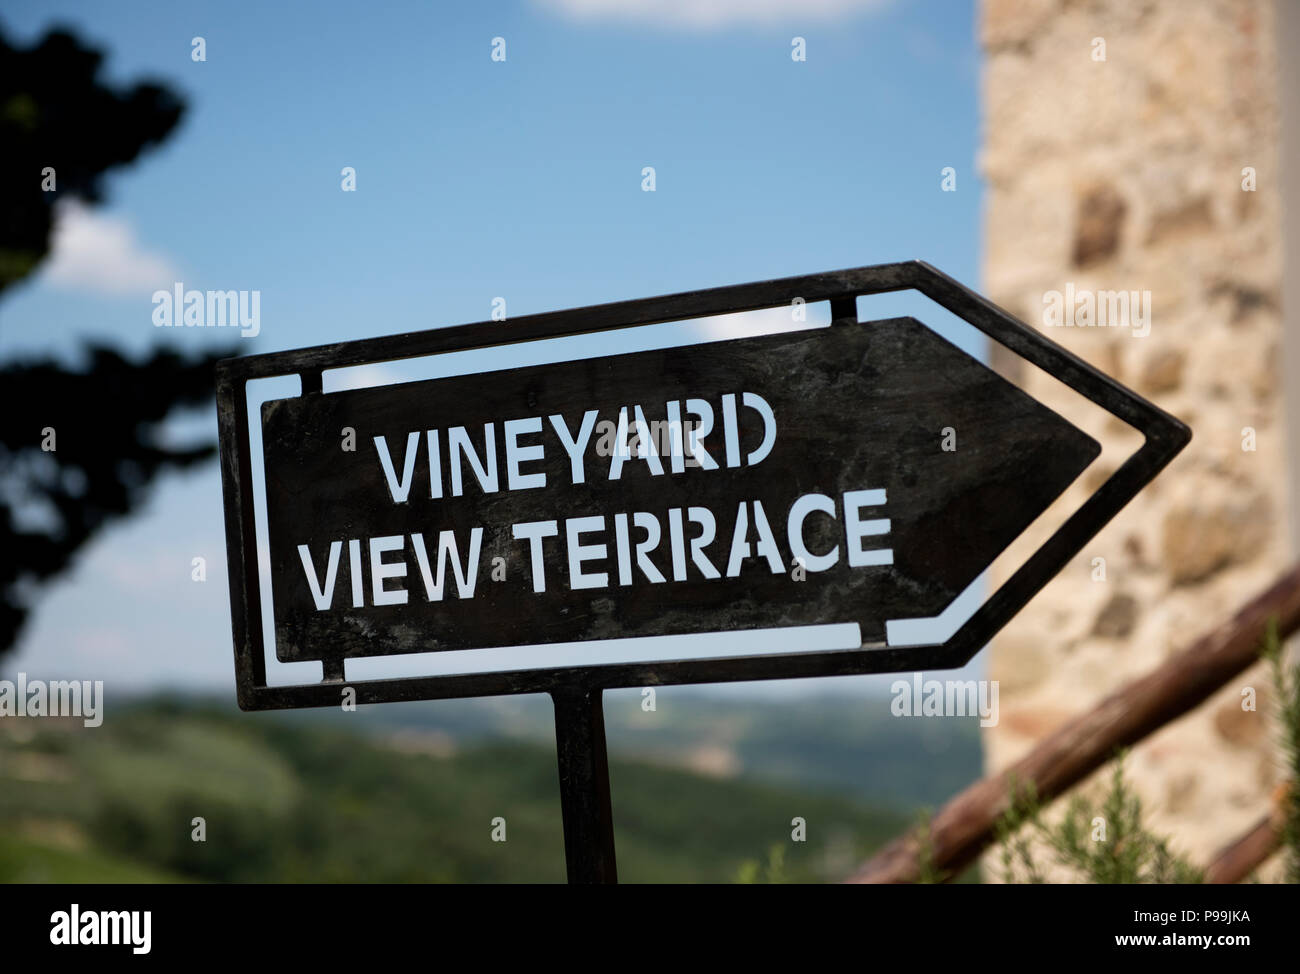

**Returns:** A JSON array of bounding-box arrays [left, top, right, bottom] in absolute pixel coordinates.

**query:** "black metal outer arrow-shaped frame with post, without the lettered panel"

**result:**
[[217, 260, 1191, 882]]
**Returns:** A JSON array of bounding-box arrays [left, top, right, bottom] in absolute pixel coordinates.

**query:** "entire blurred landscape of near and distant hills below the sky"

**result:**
[[0, 691, 980, 883]]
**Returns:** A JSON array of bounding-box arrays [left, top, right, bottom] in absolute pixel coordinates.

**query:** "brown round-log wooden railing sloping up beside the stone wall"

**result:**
[[849, 564, 1300, 883]]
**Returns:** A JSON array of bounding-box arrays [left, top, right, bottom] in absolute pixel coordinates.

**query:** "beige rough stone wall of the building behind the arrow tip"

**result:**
[[982, 0, 1292, 862]]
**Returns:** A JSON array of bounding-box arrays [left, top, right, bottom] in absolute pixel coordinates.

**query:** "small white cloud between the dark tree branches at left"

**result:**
[[43, 200, 179, 296]]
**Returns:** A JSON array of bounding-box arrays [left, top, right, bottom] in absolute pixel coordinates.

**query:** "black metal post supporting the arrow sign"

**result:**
[[551, 689, 619, 883]]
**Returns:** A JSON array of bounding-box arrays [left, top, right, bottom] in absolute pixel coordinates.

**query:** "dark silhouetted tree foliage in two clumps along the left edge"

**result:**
[[0, 30, 228, 654]]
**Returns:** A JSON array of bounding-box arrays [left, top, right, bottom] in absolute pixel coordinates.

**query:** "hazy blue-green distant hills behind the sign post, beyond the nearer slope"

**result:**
[[276, 687, 983, 809]]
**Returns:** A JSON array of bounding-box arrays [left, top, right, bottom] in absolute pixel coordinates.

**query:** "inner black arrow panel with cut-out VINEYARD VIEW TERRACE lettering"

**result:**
[[263, 319, 1100, 661]]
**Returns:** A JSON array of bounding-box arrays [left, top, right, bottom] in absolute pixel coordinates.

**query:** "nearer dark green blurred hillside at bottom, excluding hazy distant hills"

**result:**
[[0, 701, 910, 882]]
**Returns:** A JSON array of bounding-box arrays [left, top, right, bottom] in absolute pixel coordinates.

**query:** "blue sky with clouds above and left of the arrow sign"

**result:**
[[0, 0, 982, 692]]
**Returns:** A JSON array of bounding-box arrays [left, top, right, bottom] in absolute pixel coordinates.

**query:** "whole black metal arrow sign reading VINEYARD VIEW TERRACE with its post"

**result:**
[[217, 263, 1190, 879]]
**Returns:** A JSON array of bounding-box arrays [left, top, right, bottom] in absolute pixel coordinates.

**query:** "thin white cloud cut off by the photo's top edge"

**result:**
[[538, 0, 891, 30]]
